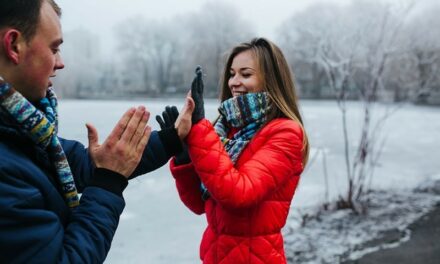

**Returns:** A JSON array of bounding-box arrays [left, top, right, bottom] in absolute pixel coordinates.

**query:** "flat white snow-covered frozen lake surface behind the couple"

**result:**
[[60, 99, 440, 263]]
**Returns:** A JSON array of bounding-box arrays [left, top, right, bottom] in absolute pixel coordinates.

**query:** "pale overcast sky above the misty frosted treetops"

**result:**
[[57, 0, 350, 54]]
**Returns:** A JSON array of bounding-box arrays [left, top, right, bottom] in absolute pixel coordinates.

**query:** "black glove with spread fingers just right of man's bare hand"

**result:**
[[156, 106, 191, 165]]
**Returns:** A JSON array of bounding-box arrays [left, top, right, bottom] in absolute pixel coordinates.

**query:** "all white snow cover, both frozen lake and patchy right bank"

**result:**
[[60, 99, 440, 264]]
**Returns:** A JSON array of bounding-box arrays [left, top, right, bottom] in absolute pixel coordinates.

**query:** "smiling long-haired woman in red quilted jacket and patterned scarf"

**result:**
[[170, 38, 309, 263]]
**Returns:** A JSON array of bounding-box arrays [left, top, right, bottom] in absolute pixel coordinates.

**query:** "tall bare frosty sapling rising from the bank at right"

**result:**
[[280, 1, 412, 211]]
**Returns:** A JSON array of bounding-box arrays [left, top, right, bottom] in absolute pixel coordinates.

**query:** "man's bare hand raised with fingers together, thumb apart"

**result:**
[[86, 106, 151, 178]]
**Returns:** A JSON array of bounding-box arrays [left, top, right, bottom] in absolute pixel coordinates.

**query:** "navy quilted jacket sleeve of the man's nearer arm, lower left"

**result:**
[[0, 164, 125, 263]]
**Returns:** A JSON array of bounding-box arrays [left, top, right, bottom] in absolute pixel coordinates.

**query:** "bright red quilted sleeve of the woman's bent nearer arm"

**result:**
[[187, 118, 303, 208]]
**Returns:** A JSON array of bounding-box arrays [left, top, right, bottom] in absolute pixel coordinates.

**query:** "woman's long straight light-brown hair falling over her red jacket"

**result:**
[[220, 38, 309, 166]]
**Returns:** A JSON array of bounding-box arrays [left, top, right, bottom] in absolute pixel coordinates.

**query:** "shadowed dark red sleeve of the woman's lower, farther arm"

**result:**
[[170, 159, 205, 214]]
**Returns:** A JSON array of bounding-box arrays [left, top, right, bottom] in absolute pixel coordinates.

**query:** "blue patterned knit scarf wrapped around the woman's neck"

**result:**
[[201, 92, 269, 200]]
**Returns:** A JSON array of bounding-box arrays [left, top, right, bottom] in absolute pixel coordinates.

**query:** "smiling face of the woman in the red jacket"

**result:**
[[228, 50, 263, 97]]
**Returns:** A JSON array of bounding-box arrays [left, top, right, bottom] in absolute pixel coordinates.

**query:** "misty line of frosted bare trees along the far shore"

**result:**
[[56, 1, 440, 104]]
